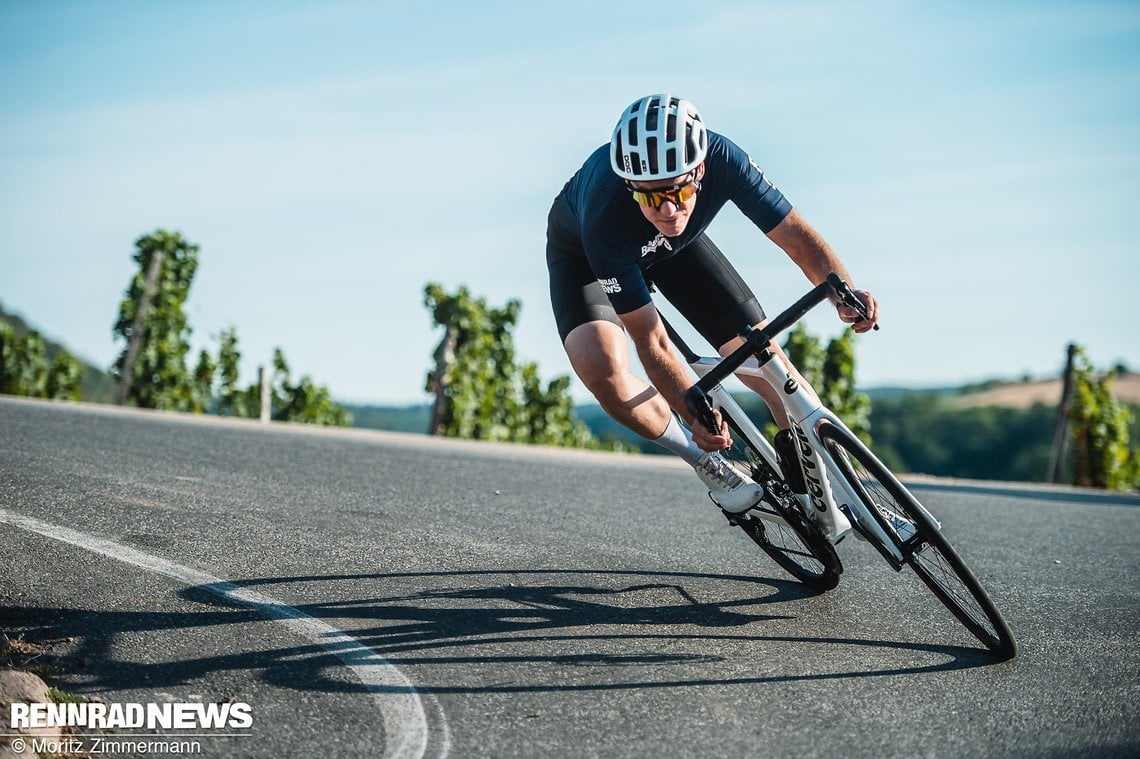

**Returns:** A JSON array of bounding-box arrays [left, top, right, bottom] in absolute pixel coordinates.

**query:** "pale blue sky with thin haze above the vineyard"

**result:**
[[0, 0, 1140, 403]]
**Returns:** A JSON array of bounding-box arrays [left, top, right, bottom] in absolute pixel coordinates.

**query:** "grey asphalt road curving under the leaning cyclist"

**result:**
[[0, 398, 1140, 759]]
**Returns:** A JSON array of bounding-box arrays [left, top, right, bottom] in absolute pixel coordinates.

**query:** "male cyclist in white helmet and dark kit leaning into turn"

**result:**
[[546, 95, 878, 513]]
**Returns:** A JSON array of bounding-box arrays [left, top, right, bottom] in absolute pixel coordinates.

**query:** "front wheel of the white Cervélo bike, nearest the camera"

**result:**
[[819, 424, 1017, 659]]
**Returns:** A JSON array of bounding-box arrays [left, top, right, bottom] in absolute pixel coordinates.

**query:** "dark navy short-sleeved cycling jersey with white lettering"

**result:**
[[559, 132, 791, 313]]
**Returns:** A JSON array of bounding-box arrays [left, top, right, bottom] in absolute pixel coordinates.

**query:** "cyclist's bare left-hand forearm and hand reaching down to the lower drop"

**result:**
[[620, 303, 732, 450]]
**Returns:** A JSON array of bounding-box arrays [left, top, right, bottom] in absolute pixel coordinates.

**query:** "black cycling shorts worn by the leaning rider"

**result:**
[[546, 203, 764, 348]]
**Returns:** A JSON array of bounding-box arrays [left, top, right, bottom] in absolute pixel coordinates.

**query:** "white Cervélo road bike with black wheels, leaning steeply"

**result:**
[[666, 274, 1017, 659]]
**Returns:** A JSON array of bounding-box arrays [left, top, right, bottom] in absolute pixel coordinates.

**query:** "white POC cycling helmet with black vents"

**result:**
[[610, 95, 709, 182]]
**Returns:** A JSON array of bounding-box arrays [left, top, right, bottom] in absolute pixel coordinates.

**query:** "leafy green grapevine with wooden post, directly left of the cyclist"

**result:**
[[424, 283, 626, 449]]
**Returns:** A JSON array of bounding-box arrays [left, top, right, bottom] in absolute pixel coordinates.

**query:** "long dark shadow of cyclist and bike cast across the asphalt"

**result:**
[[0, 570, 994, 694]]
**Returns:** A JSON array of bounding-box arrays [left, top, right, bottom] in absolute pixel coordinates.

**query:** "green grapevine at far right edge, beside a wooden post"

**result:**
[[1069, 348, 1140, 490]]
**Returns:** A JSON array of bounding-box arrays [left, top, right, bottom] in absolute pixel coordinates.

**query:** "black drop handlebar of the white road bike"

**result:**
[[685, 271, 879, 431]]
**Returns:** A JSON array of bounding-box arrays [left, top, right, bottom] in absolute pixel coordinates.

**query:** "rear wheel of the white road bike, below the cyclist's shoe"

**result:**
[[720, 408, 844, 593]]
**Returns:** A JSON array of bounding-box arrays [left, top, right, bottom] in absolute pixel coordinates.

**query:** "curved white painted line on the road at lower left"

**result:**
[[0, 508, 450, 759]]
